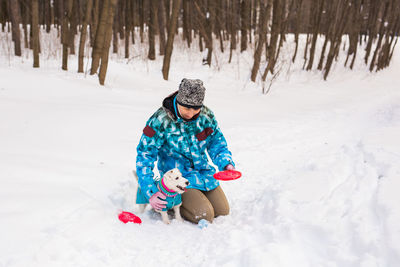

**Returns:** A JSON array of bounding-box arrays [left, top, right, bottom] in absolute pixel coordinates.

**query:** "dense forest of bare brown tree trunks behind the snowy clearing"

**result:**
[[0, 0, 400, 90]]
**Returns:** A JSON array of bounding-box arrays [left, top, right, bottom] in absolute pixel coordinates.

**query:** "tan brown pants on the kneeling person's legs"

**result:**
[[180, 186, 229, 223]]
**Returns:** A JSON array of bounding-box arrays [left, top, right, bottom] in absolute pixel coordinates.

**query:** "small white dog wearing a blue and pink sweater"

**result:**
[[134, 168, 189, 224]]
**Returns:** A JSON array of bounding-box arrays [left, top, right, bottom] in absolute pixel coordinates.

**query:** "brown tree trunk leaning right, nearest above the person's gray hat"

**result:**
[[162, 0, 181, 80]]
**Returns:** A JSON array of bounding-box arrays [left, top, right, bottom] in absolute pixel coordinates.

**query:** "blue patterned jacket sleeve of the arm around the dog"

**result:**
[[136, 115, 164, 199]]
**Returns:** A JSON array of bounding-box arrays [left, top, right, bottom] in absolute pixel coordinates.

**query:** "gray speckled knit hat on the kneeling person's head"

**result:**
[[176, 79, 206, 109]]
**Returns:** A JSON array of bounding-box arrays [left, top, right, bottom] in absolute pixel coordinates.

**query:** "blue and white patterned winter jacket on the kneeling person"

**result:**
[[136, 92, 234, 203]]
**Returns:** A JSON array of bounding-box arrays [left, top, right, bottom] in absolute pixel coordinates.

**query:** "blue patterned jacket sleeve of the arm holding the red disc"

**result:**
[[207, 111, 235, 171]]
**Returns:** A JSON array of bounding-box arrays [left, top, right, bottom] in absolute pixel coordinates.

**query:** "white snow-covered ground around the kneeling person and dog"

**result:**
[[0, 34, 400, 267]]
